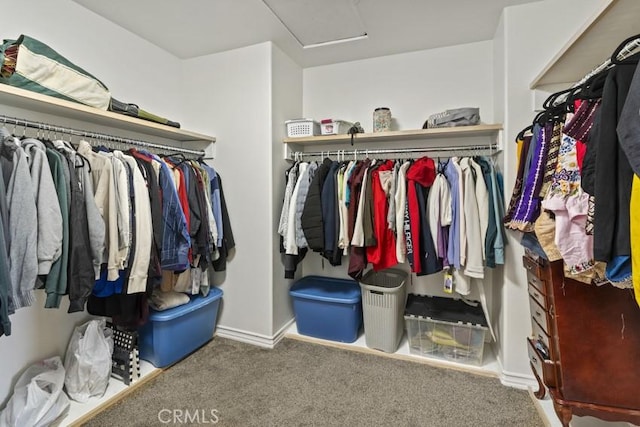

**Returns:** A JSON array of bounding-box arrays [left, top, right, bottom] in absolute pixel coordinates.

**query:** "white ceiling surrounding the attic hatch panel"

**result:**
[[74, 0, 539, 67]]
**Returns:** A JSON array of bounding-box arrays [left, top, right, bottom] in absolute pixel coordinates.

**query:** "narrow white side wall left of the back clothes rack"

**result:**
[[271, 45, 302, 335]]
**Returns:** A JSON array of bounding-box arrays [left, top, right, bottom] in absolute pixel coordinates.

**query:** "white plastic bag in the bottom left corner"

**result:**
[[0, 356, 69, 427]]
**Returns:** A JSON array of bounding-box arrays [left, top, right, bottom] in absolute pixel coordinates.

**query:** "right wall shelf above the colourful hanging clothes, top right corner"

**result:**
[[529, 0, 640, 89]]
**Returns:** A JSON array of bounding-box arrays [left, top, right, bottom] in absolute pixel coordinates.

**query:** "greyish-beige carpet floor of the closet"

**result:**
[[81, 338, 543, 427]]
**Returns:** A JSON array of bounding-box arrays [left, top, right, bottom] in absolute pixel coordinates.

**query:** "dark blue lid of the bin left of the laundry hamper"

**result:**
[[289, 276, 361, 304]]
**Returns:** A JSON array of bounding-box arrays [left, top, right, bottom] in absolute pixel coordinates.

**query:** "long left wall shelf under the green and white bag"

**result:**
[[0, 84, 216, 143]]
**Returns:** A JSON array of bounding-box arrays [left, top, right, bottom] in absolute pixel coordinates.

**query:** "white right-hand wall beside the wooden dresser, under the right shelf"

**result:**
[[495, 0, 605, 383]]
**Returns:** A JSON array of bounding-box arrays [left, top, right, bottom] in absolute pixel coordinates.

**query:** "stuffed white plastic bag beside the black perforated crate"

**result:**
[[64, 319, 113, 403]]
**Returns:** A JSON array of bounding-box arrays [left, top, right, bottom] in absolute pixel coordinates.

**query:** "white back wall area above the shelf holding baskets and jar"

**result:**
[[303, 41, 493, 132]]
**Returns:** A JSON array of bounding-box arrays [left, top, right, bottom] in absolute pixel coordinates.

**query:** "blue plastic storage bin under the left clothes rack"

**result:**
[[138, 287, 222, 368]]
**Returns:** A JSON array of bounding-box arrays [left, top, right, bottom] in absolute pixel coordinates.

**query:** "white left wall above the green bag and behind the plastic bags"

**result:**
[[0, 0, 188, 407]]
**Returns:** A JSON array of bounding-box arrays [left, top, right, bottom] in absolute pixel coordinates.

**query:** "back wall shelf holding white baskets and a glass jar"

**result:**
[[283, 124, 502, 145]]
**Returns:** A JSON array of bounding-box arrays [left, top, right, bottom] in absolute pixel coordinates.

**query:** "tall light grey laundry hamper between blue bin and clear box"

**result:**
[[360, 269, 407, 353]]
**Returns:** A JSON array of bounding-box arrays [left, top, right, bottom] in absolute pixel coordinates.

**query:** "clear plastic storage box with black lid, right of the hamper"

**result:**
[[404, 295, 488, 365]]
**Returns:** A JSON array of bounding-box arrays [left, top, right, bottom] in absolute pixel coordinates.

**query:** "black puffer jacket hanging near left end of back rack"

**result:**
[[301, 158, 332, 252]]
